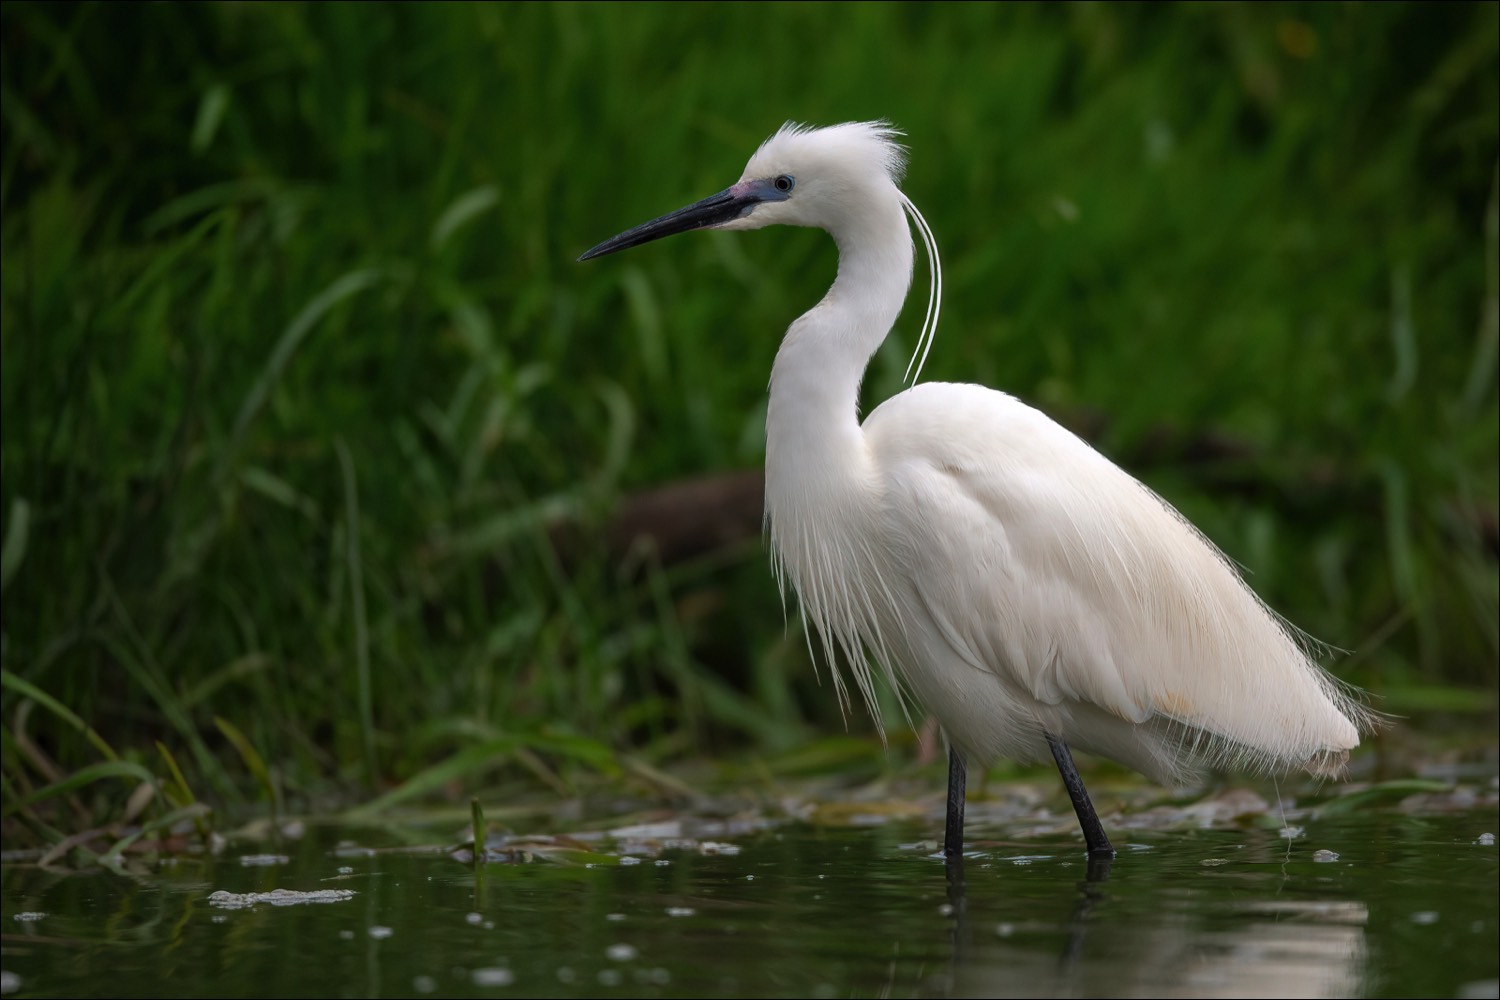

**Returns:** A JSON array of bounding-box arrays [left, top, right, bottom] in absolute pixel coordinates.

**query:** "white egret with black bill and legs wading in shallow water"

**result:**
[[579, 121, 1374, 858]]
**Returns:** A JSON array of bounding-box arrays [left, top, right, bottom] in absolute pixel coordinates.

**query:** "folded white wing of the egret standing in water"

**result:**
[[866, 384, 1359, 771]]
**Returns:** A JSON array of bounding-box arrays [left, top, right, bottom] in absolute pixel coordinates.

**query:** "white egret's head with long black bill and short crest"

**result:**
[[578, 121, 906, 261]]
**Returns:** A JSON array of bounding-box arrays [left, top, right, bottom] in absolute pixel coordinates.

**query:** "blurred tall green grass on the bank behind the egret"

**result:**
[[0, 3, 1500, 845]]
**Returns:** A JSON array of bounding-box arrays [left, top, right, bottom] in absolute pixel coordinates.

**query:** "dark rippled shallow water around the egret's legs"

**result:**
[[0, 805, 1500, 997]]
